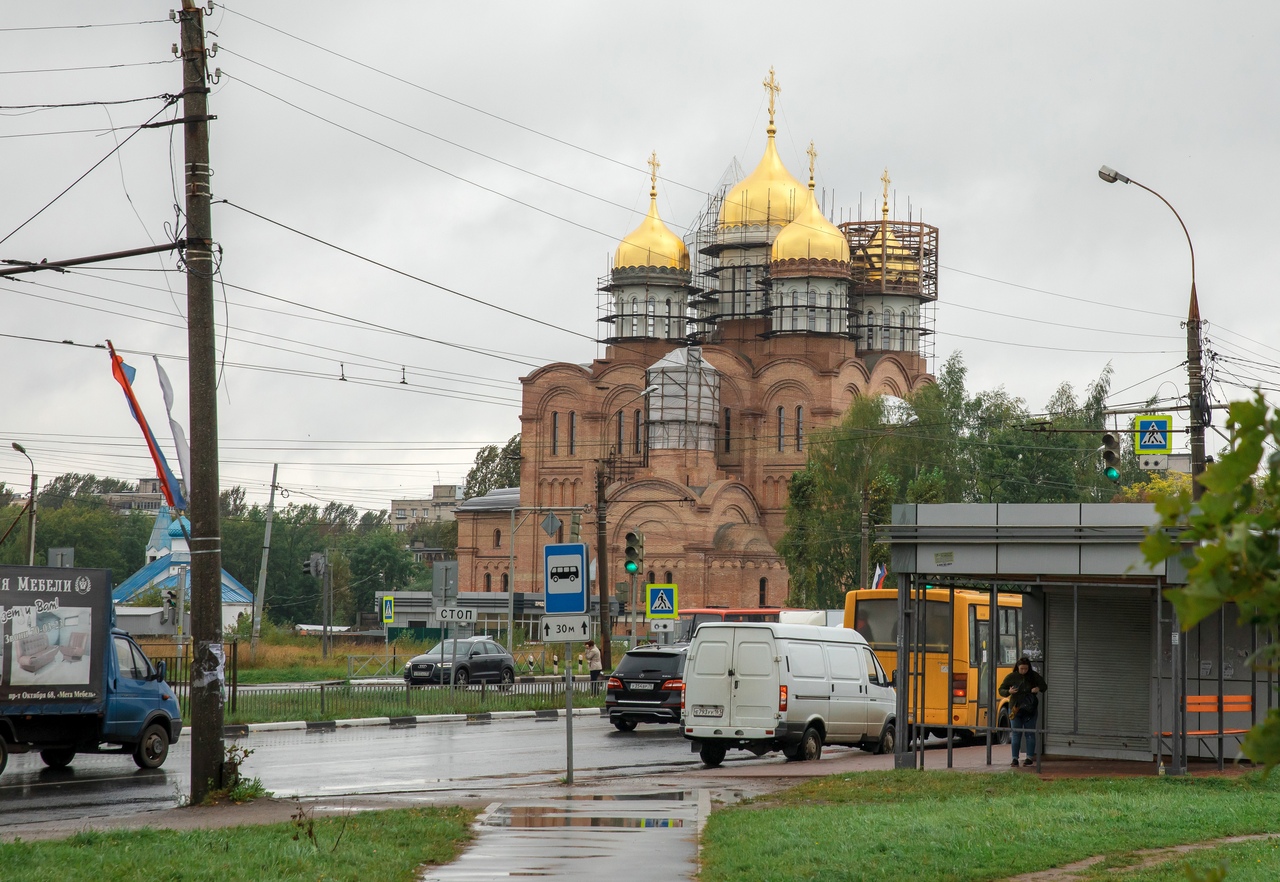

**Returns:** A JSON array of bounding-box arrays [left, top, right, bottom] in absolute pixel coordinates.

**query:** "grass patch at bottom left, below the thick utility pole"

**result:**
[[0, 808, 475, 882]]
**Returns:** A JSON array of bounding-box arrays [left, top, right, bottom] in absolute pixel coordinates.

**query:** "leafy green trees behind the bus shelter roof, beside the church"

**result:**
[[778, 355, 1116, 608]]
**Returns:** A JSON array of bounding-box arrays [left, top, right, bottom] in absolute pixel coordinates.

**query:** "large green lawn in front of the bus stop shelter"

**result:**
[[699, 769, 1280, 882]]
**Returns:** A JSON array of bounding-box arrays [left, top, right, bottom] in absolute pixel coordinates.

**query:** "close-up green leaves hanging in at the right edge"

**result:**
[[1143, 392, 1280, 771]]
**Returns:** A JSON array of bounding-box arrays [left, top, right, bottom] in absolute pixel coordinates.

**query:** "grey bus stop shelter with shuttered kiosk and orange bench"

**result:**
[[878, 503, 1276, 774]]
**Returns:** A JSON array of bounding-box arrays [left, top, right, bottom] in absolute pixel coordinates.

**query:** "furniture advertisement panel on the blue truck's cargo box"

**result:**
[[0, 567, 111, 710]]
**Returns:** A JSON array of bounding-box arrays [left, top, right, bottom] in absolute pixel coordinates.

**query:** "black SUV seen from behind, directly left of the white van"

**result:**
[[604, 643, 689, 732]]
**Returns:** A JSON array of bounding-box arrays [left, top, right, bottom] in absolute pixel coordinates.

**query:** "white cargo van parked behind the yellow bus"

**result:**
[[684, 622, 897, 767]]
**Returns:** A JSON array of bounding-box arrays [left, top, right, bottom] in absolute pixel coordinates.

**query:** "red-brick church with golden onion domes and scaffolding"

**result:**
[[457, 70, 938, 619]]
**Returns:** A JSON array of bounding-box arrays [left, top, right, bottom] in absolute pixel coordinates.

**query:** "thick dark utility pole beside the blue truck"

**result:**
[[178, 0, 225, 805]]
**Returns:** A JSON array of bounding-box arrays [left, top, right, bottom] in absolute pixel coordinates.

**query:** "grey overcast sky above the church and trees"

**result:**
[[0, 0, 1280, 511]]
